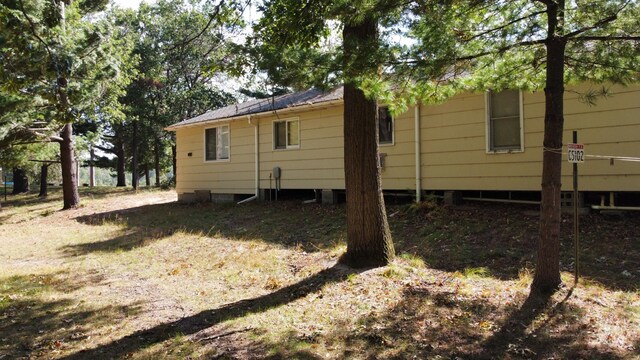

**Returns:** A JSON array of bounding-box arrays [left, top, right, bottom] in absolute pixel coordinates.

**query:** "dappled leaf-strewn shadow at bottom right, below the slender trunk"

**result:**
[[326, 286, 626, 359]]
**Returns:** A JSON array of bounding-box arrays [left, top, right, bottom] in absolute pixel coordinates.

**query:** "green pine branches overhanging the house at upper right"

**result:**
[[378, 0, 640, 106]]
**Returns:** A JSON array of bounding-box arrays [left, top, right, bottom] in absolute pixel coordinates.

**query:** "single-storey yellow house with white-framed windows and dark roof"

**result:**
[[167, 84, 640, 207]]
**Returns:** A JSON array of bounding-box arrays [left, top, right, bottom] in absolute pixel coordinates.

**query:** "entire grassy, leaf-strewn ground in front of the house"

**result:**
[[0, 188, 640, 359]]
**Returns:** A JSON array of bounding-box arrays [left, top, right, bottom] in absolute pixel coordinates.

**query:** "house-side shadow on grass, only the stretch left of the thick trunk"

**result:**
[[63, 202, 345, 256]]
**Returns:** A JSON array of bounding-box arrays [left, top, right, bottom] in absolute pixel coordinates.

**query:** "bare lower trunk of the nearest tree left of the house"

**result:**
[[60, 123, 80, 210]]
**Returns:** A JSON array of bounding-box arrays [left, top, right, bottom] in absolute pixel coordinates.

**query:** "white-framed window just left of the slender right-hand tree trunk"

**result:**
[[487, 90, 523, 152]]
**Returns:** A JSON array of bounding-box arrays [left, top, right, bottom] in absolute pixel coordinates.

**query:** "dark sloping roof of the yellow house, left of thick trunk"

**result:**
[[167, 86, 343, 130]]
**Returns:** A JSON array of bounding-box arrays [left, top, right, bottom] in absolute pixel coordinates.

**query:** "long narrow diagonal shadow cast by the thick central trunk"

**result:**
[[57, 265, 354, 359]]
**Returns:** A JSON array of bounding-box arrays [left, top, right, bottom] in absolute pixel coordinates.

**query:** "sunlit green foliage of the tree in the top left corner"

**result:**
[[0, 0, 135, 175]]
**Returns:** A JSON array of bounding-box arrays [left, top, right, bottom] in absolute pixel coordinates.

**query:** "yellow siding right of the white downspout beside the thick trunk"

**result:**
[[421, 85, 640, 191]]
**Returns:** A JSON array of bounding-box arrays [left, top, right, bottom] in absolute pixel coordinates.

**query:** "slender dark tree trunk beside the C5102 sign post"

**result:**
[[531, 1, 566, 294]]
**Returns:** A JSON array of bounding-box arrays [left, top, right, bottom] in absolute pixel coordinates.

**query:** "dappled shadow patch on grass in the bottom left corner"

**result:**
[[0, 272, 138, 359]]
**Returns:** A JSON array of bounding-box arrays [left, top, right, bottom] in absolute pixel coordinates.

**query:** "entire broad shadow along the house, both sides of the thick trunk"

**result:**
[[64, 201, 640, 291]]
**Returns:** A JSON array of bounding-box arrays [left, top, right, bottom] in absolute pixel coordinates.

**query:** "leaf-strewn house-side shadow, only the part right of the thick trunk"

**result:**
[[388, 204, 640, 291]]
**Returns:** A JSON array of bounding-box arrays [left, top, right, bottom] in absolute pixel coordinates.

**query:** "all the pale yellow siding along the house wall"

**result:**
[[177, 86, 640, 194]]
